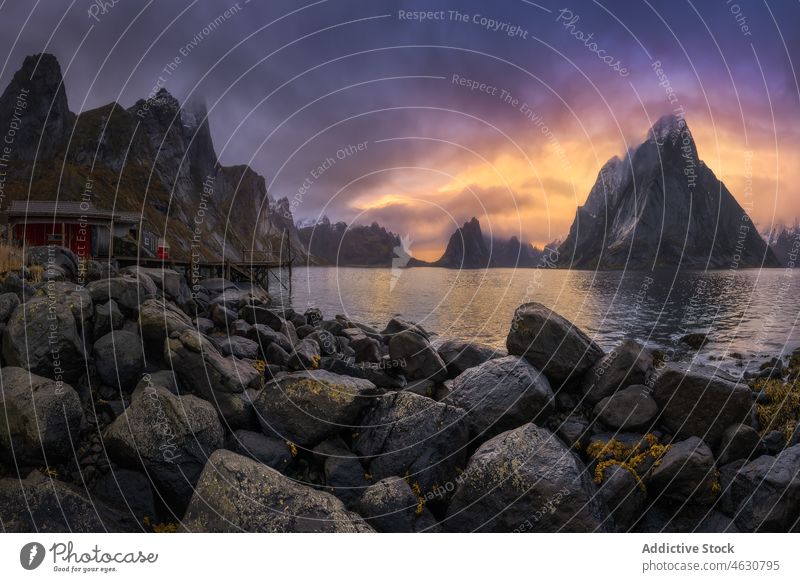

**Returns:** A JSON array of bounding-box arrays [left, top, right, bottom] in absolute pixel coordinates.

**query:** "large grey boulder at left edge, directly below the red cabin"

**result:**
[[3, 282, 93, 382]]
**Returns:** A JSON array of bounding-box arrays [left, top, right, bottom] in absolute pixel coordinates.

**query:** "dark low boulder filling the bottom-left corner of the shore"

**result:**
[[0, 471, 141, 535]]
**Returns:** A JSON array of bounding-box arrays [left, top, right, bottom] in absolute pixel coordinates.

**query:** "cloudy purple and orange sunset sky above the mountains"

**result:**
[[0, 0, 800, 259]]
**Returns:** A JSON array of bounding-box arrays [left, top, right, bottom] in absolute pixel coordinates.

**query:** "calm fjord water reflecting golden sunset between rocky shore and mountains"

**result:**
[[270, 267, 800, 374]]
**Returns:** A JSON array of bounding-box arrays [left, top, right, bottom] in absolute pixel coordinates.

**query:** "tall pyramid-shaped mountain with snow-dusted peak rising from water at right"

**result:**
[[559, 115, 779, 269]]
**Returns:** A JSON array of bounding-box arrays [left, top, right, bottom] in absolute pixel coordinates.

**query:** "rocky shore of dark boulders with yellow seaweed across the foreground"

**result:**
[[0, 249, 800, 532]]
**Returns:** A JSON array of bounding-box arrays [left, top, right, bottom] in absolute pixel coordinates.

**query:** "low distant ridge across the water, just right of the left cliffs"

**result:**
[[298, 216, 404, 267]]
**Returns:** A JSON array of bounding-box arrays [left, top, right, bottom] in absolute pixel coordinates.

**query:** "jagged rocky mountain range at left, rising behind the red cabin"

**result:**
[[0, 54, 306, 259]]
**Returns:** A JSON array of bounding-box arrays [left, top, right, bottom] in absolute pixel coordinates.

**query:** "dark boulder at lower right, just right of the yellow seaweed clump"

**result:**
[[647, 437, 719, 504]]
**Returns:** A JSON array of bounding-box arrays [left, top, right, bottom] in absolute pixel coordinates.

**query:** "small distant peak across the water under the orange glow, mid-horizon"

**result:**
[[408, 217, 542, 269]]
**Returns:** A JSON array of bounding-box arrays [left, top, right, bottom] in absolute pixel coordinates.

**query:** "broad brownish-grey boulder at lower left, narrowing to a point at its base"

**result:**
[[103, 385, 225, 509]]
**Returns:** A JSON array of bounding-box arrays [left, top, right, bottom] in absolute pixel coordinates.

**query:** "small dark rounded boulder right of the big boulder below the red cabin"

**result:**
[[94, 331, 144, 391]]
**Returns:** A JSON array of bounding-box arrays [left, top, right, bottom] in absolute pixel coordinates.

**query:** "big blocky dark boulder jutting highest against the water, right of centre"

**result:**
[[506, 303, 603, 385]]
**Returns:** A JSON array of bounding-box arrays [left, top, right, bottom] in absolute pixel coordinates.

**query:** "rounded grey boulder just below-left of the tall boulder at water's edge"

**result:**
[[450, 356, 553, 440]]
